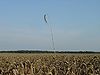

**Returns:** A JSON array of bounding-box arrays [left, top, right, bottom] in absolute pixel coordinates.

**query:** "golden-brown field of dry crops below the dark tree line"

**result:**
[[0, 53, 100, 75]]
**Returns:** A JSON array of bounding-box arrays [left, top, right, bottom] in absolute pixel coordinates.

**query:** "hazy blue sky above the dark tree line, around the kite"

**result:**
[[0, 0, 100, 51]]
